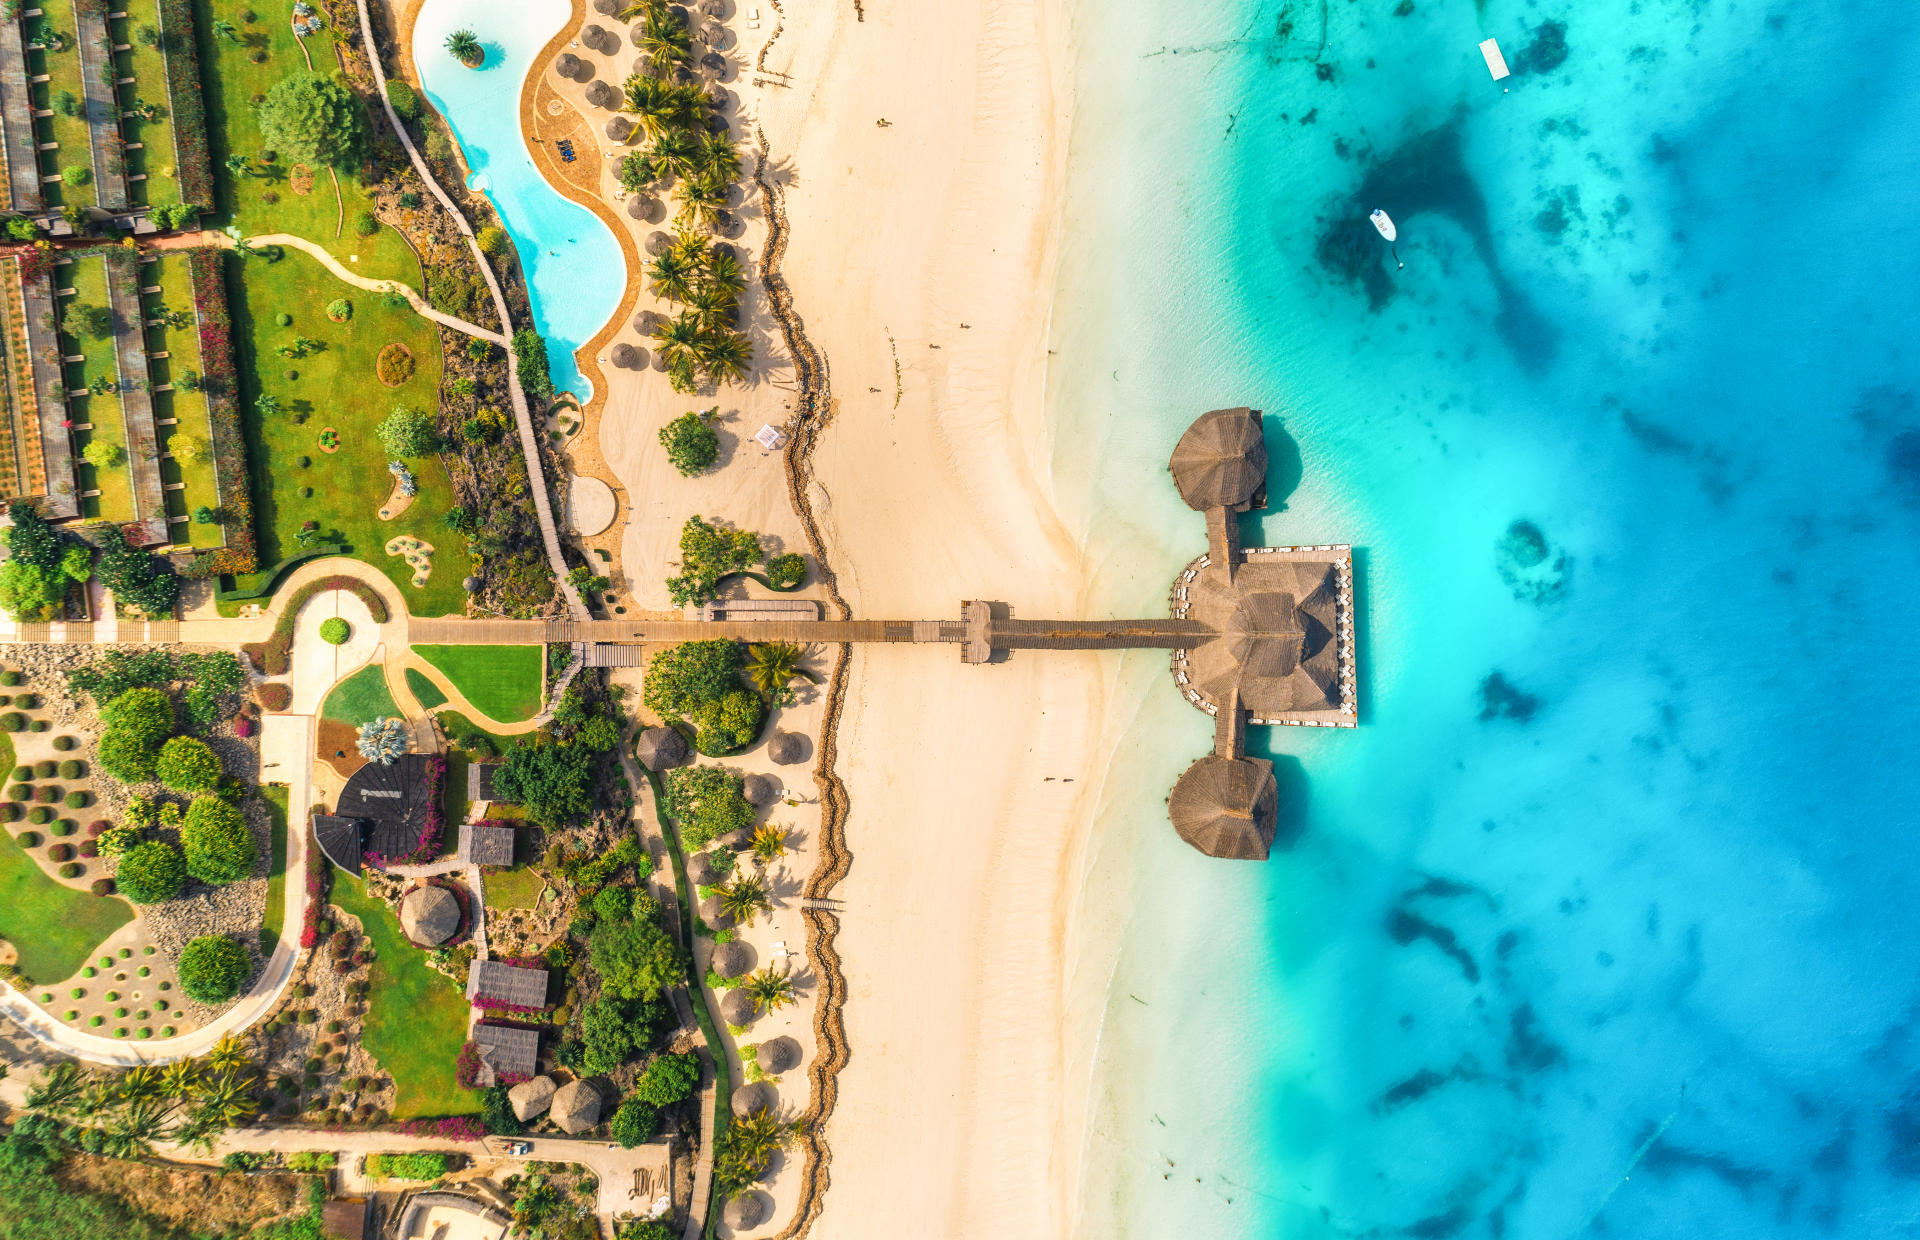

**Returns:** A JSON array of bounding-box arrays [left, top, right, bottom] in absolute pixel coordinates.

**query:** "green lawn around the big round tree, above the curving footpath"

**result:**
[[194, 0, 416, 284]]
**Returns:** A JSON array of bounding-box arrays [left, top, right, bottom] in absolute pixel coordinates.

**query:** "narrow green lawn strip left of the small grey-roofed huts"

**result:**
[[332, 870, 480, 1119]]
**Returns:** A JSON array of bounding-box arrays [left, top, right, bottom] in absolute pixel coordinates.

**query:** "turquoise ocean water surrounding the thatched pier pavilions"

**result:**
[[1050, 0, 1920, 1240]]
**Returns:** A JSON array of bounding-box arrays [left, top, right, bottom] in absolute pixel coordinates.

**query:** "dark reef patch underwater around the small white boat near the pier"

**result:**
[[1313, 121, 1559, 372]]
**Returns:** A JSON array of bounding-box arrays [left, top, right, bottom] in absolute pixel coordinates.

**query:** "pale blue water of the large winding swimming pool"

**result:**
[[413, 0, 626, 397]]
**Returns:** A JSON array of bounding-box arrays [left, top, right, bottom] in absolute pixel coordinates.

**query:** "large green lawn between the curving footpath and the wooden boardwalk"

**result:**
[[227, 250, 467, 616]]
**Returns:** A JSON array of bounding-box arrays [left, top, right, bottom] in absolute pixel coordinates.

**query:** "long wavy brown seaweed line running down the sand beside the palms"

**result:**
[[753, 129, 852, 1240]]
